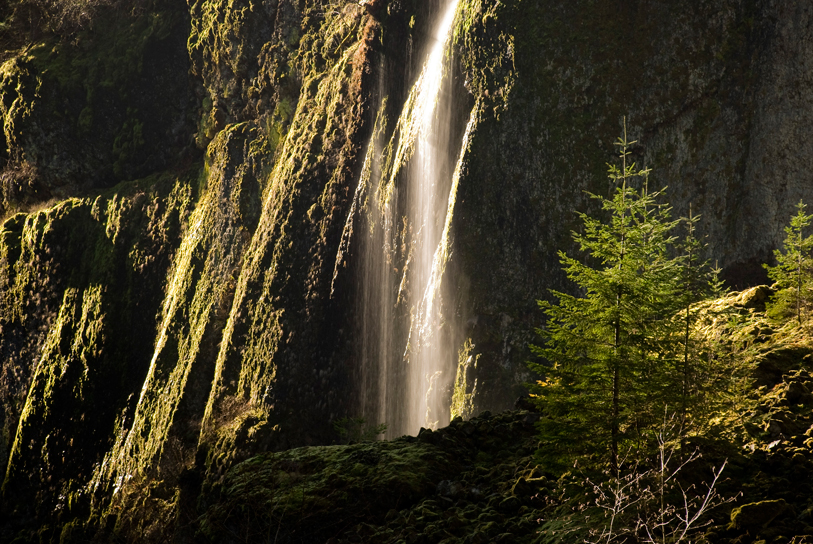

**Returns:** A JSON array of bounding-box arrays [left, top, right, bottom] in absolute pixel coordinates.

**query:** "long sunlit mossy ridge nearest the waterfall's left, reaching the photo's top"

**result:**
[[204, 1, 372, 454]]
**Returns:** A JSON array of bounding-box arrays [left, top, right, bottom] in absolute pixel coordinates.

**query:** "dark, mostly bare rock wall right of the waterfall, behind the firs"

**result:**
[[455, 1, 813, 409]]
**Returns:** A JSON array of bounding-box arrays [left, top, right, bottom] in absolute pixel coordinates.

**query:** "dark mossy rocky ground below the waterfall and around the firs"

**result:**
[[186, 402, 813, 544]]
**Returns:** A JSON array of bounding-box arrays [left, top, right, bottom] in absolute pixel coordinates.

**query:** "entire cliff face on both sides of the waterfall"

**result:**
[[0, 0, 813, 541]]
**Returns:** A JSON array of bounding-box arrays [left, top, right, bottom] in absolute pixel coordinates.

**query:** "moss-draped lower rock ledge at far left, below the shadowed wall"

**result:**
[[0, 171, 198, 519]]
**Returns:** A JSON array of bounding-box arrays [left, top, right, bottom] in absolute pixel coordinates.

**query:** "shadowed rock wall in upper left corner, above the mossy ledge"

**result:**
[[0, 0, 196, 216]]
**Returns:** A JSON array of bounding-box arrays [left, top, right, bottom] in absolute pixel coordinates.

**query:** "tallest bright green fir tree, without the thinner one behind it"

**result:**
[[532, 125, 678, 471]]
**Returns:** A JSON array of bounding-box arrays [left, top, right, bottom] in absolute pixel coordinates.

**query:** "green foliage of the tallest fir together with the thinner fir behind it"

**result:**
[[530, 125, 711, 471]]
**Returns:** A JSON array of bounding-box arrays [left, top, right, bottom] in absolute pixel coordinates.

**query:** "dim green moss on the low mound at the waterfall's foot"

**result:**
[[196, 442, 453, 541]]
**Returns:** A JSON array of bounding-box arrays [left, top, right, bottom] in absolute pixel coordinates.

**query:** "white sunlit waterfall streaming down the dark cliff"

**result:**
[[345, 0, 465, 437]]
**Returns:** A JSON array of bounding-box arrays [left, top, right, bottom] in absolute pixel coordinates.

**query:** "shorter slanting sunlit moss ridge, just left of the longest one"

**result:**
[[94, 121, 258, 516]]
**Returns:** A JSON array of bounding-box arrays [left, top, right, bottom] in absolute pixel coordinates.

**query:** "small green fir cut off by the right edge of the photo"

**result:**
[[764, 200, 813, 325]]
